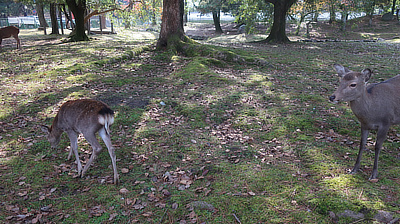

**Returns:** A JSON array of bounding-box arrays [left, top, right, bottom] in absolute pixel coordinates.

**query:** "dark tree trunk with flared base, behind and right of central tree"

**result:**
[[265, 0, 296, 43]]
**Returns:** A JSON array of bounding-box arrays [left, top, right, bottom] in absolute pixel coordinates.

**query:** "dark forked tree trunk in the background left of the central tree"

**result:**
[[66, 0, 89, 41]]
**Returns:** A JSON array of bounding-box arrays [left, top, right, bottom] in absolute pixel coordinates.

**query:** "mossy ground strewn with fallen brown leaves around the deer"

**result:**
[[0, 16, 400, 224]]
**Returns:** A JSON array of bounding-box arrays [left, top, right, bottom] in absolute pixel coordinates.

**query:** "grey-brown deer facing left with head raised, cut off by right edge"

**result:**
[[329, 64, 400, 180]]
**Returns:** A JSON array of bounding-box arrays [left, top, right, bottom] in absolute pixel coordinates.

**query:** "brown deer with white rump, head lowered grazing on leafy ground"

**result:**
[[42, 99, 119, 184]]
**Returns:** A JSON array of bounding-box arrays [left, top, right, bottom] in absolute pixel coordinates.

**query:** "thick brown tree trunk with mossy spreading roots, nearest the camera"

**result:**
[[157, 0, 186, 49]]
